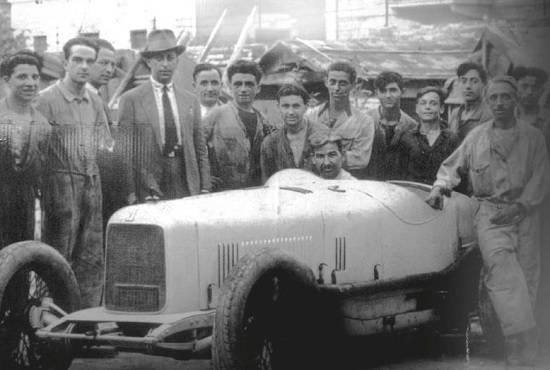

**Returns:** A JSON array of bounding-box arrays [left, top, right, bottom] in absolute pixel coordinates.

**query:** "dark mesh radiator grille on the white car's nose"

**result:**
[[105, 224, 166, 312]]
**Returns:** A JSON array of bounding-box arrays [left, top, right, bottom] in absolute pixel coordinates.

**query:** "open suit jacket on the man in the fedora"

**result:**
[[119, 81, 211, 195]]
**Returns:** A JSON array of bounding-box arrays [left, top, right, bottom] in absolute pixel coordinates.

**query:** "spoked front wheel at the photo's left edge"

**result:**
[[0, 241, 79, 370]]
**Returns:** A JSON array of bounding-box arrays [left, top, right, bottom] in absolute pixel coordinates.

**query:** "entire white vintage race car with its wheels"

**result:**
[[0, 170, 479, 369]]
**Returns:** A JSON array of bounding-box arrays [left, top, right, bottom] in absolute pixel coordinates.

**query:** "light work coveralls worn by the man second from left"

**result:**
[[38, 81, 109, 308]]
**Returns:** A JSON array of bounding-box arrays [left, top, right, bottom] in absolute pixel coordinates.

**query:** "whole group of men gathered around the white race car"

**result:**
[[0, 26, 550, 364]]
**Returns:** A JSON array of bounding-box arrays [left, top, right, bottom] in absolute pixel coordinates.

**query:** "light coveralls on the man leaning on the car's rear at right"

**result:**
[[434, 120, 550, 336]]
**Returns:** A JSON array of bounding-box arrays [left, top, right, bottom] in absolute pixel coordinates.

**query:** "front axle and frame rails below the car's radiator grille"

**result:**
[[36, 307, 215, 359]]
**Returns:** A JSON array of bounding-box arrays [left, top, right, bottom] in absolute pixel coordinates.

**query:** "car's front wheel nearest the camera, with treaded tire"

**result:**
[[212, 249, 318, 370]]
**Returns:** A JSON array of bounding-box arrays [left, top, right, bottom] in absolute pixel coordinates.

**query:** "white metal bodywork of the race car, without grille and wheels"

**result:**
[[111, 171, 472, 313]]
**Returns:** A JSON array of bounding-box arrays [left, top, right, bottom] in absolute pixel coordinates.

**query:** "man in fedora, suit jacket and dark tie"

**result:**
[[119, 30, 210, 203]]
